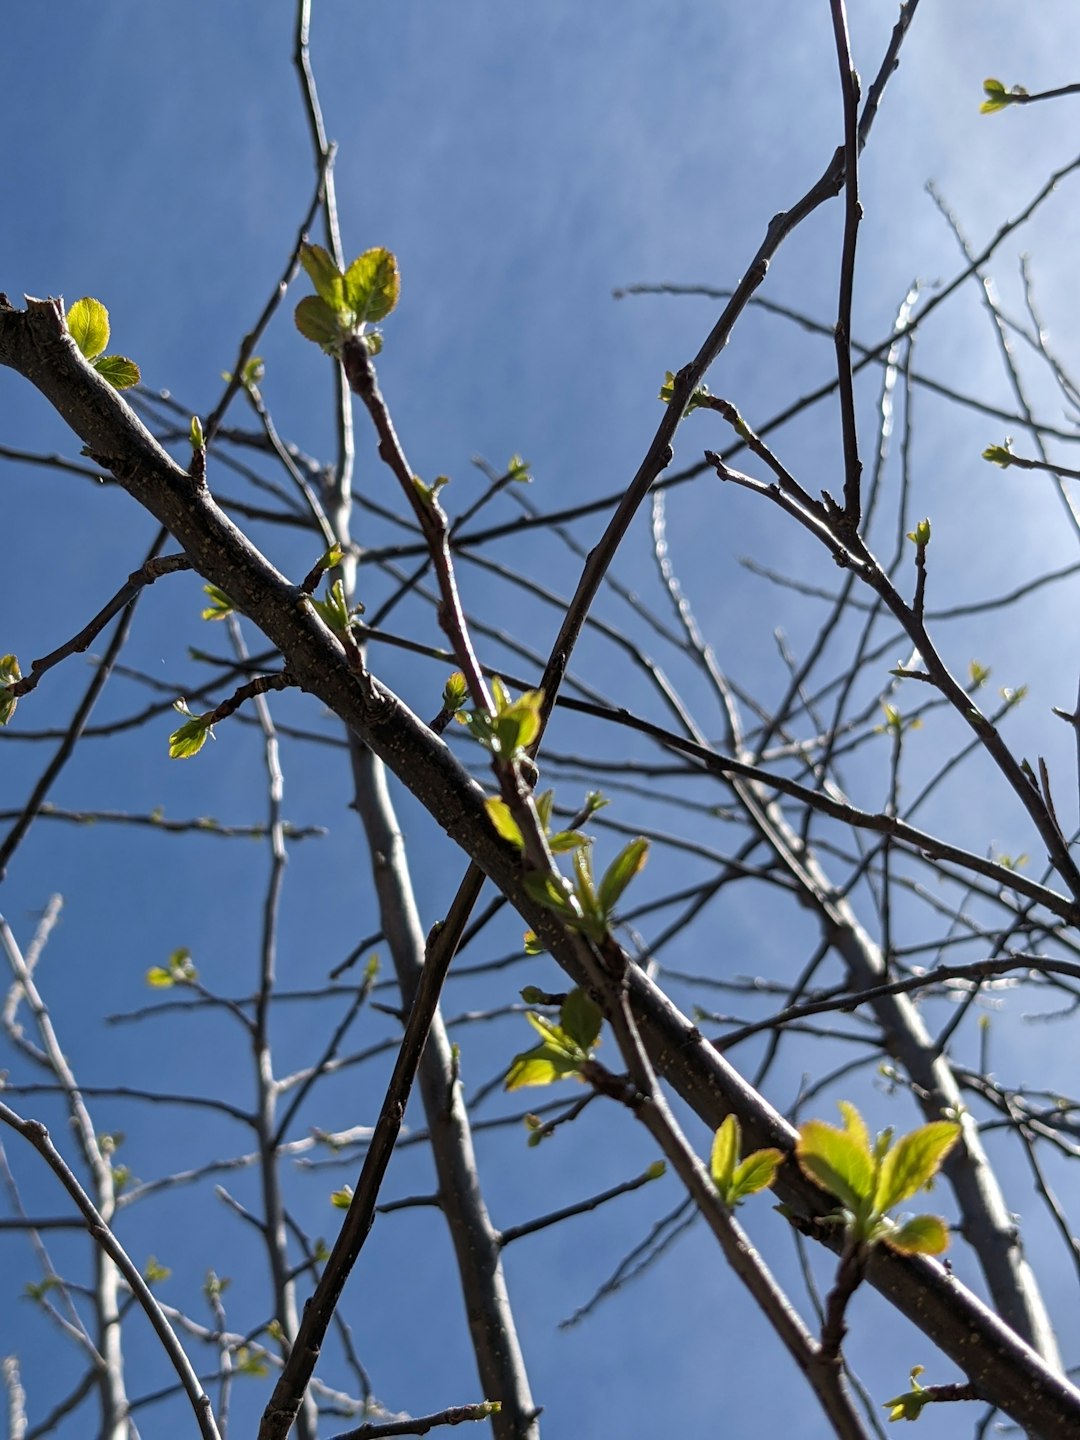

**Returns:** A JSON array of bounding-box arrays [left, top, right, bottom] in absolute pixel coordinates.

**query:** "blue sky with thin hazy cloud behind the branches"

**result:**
[[0, 0, 1080, 1440]]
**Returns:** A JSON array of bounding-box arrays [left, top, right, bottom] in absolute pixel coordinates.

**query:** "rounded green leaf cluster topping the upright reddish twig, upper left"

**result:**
[[295, 245, 402, 356]]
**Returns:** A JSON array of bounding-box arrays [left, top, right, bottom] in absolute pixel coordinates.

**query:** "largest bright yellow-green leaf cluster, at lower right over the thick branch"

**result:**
[[795, 1100, 960, 1256]]
